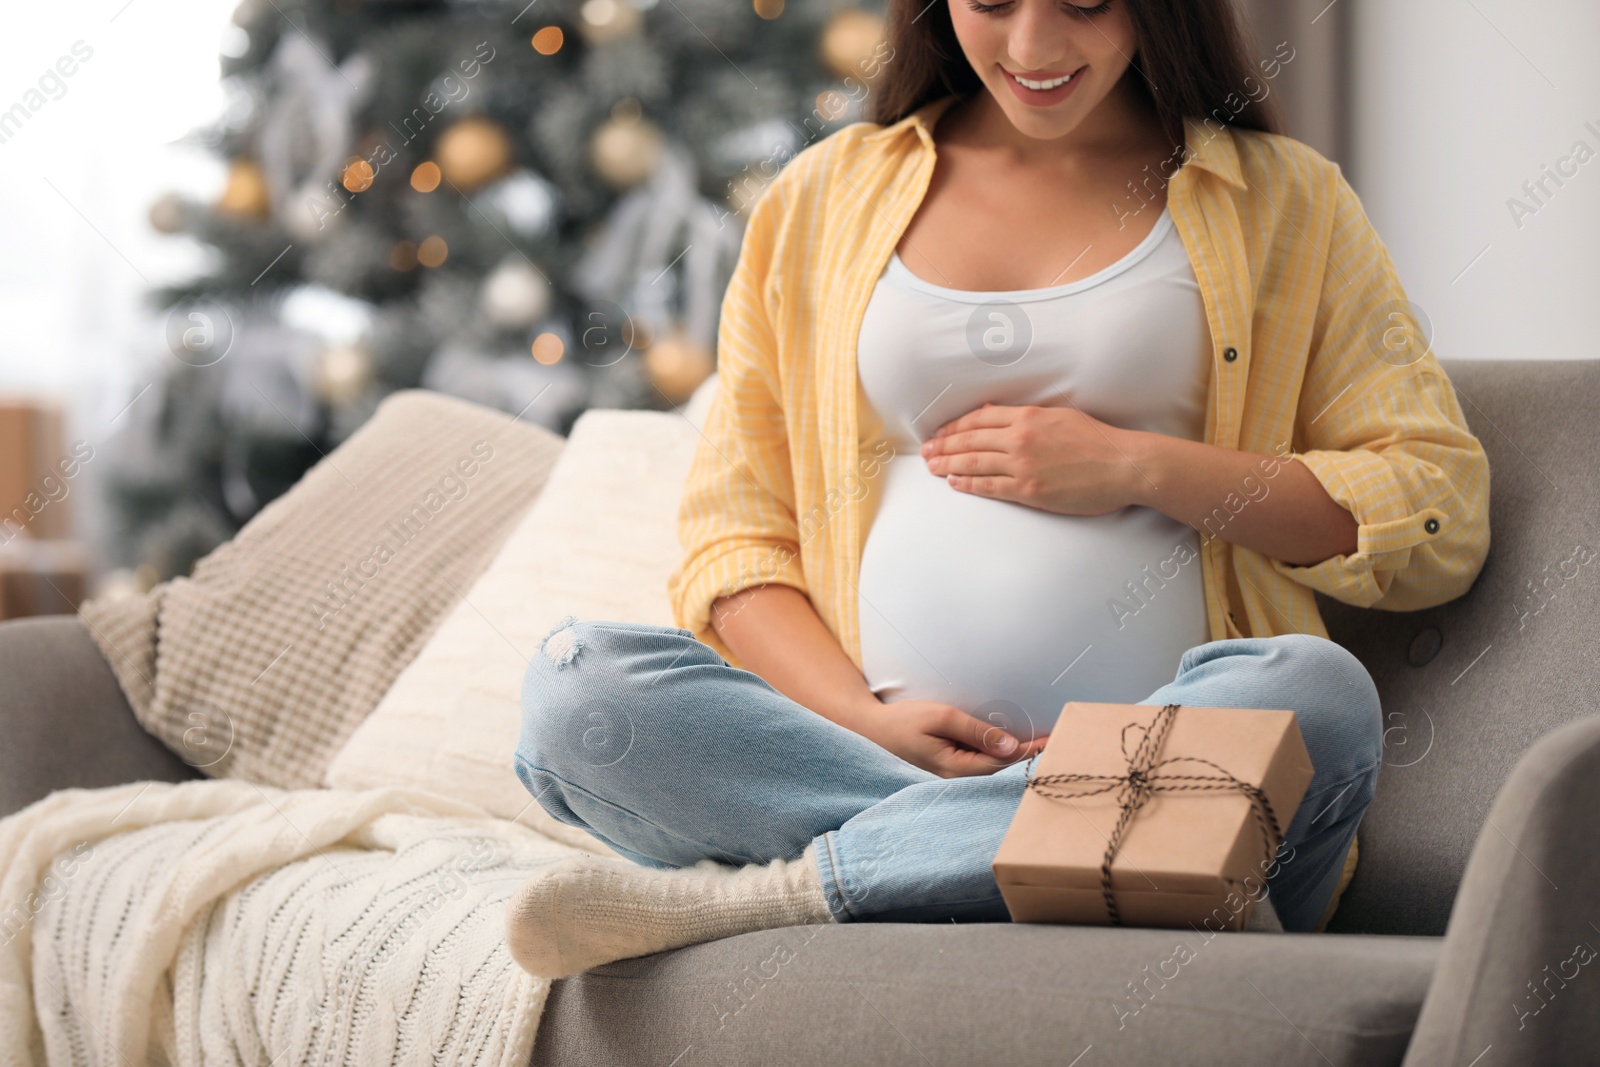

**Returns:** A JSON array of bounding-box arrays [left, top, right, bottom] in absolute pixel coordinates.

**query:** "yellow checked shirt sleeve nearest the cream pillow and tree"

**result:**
[[667, 170, 806, 665]]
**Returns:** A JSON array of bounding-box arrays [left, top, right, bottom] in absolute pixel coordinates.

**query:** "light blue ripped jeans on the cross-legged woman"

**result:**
[[515, 616, 1382, 931]]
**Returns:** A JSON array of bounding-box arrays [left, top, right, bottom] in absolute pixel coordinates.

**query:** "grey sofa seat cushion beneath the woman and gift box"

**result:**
[[533, 923, 1440, 1067]]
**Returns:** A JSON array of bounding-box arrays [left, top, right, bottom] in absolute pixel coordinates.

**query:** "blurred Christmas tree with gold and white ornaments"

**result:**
[[110, 0, 886, 585]]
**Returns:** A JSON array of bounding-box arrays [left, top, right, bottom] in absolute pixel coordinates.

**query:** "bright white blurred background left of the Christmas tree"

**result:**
[[0, 0, 232, 409]]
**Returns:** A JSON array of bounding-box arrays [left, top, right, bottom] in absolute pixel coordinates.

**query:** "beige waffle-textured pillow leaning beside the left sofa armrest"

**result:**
[[80, 390, 565, 789]]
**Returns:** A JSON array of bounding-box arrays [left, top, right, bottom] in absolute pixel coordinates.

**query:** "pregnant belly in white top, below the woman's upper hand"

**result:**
[[858, 453, 1210, 737]]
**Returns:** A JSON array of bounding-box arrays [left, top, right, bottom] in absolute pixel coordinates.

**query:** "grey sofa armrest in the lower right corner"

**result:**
[[1405, 717, 1600, 1067]]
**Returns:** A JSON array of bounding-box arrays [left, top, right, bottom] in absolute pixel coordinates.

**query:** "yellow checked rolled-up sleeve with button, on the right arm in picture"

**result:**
[[1272, 176, 1490, 611]]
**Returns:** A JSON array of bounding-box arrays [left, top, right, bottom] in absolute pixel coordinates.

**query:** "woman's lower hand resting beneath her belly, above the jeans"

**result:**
[[850, 701, 1046, 777]]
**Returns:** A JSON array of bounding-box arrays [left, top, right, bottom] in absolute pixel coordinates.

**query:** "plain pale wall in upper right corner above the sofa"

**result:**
[[1344, 0, 1600, 358]]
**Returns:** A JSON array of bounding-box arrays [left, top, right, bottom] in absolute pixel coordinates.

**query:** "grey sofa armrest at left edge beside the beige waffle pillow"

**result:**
[[0, 616, 200, 817]]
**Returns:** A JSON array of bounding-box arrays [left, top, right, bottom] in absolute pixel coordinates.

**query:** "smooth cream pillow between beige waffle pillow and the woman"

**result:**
[[326, 399, 710, 825]]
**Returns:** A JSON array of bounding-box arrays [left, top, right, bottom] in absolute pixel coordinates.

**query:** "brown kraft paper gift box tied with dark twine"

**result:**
[[994, 702, 1312, 929]]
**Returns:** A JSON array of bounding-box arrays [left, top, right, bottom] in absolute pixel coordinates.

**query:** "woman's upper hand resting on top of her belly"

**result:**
[[922, 403, 1144, 515]]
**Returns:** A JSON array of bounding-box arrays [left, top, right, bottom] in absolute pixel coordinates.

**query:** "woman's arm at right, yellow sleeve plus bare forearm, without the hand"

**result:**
[[1117, 176, 1488, 598]]
